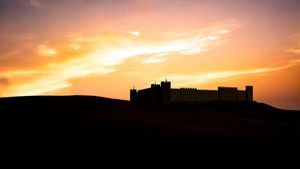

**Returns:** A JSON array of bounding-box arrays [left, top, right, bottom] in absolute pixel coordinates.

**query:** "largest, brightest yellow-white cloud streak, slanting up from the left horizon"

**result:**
[[1, 25, 232, 96]]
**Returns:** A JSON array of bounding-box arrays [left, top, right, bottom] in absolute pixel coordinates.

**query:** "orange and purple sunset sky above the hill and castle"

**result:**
[[0, 0, 300, 109]]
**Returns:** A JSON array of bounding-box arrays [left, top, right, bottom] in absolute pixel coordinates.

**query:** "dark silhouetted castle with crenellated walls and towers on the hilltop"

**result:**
[[130, 80, 253, 104]]
